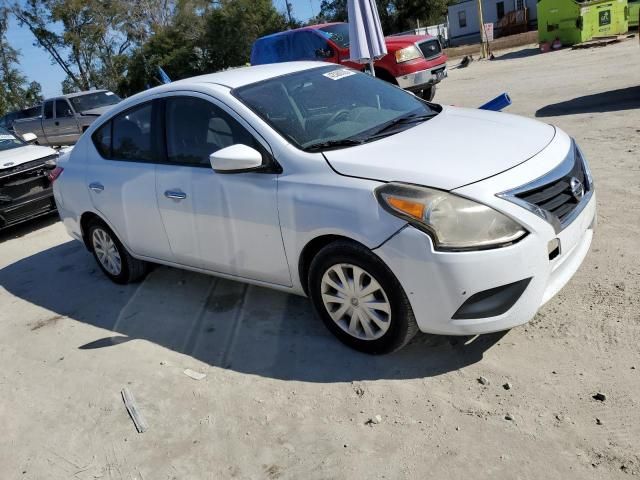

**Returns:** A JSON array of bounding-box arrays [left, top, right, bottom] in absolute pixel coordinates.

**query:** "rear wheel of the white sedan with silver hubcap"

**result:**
[[87, 219, 147, 285]]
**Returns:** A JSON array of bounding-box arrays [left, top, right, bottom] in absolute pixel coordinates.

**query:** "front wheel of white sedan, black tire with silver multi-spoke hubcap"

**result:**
[[308, 241, 418, 354]]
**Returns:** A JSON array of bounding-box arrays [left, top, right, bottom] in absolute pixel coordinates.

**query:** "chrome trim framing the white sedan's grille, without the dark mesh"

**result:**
[[496, 139, 594, 234]]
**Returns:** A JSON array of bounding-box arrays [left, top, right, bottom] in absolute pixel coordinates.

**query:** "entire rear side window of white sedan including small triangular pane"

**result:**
[[91, 102, 155, 162]]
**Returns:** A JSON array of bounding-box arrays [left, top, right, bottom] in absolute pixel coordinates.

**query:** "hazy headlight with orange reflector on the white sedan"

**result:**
[[375, 183, 527, 250]]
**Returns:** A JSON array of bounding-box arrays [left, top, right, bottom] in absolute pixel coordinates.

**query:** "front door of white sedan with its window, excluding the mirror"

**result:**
[[156, 94, 291, 285]]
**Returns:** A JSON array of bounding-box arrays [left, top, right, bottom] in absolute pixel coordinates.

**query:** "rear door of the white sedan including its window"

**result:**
[[86, 101, 171, 261]]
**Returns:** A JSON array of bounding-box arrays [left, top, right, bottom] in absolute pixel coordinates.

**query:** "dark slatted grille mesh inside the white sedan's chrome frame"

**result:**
[[516, 155, 588, 223]]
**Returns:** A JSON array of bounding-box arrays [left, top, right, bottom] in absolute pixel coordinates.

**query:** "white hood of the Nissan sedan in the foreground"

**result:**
[[324, 107, 555, 190]]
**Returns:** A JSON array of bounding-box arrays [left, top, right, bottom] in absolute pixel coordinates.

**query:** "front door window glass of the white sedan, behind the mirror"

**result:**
[[165, 97, 263, 167]]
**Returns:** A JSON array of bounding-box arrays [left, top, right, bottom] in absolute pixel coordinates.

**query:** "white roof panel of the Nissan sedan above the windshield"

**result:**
[[168, 62, 332, 89]]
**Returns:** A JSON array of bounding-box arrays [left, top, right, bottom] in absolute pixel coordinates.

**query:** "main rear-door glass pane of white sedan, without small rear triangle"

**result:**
[[111, 103, 153, 162]]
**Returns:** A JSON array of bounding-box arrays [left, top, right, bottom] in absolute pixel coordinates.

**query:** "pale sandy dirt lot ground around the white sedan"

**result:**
[[0, 41, 640, 480]]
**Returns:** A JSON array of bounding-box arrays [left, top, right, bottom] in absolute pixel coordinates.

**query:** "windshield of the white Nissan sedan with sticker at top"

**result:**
[[234, 66, 440, 151]]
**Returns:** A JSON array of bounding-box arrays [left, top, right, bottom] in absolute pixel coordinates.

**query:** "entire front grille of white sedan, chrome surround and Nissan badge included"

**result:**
[[498, 144, 593, 232]]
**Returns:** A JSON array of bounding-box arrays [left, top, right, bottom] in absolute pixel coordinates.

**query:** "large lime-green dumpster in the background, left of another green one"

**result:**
[[538, 0, 629, 45]]
